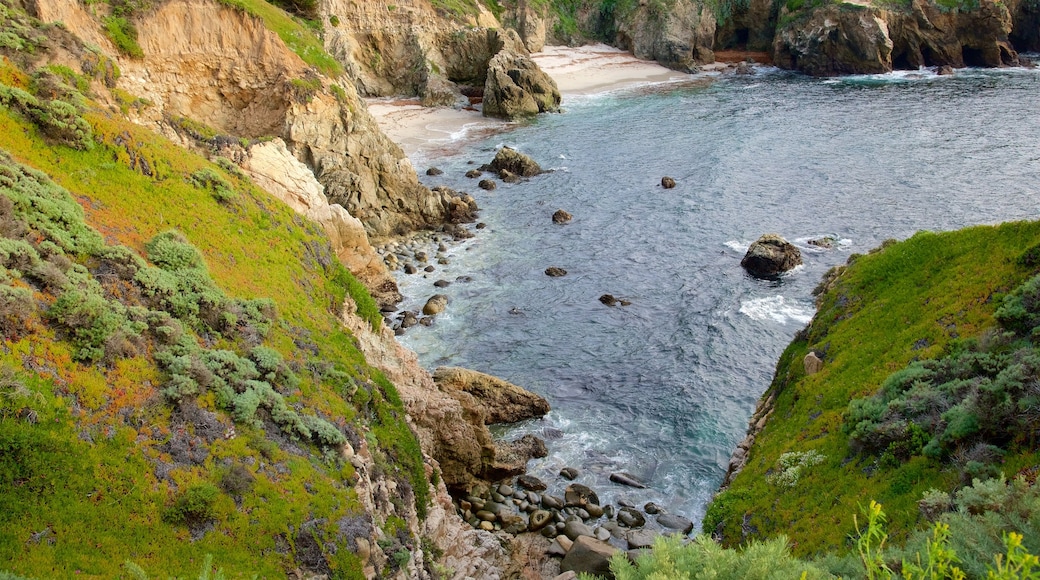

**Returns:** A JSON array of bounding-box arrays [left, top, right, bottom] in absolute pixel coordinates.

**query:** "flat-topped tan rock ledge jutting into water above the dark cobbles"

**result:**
[[434, 367, 549, 425]]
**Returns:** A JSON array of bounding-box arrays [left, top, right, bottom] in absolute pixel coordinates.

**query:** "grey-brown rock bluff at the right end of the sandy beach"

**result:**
[[615, 0, 716, 72]]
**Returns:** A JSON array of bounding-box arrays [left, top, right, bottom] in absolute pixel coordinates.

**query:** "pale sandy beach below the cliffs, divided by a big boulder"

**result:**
[[366, 45, 692, 157]]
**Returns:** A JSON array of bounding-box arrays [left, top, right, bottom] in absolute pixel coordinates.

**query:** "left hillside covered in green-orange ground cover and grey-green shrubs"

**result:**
[[0, 4, 428, 578]]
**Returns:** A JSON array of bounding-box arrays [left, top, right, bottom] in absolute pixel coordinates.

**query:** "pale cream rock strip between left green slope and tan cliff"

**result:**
[[241, 139, 401, 306]]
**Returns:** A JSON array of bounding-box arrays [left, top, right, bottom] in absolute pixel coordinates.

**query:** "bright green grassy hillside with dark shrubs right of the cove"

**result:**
[[704, 222, 1040, 555]]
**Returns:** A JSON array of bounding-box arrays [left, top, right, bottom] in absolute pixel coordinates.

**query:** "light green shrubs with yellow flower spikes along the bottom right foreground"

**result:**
[[582, 492, 1040, 580]]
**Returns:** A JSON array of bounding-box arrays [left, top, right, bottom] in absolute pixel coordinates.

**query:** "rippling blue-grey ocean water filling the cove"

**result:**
[[388, 64, 1040, 522]]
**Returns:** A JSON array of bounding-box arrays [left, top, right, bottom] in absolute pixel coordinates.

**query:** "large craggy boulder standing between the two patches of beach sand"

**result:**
[[484, 49, 561, 120]]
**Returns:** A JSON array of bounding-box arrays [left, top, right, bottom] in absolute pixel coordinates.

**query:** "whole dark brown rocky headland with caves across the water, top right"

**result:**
[[773, 0, 1029, 76]]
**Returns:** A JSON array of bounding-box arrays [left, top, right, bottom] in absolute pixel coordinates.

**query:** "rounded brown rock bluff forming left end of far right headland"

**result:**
[[773, 4, 892, 76]]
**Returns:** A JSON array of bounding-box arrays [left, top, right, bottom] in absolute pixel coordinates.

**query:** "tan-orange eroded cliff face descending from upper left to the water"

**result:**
[[35, 0, 472, 245]]
